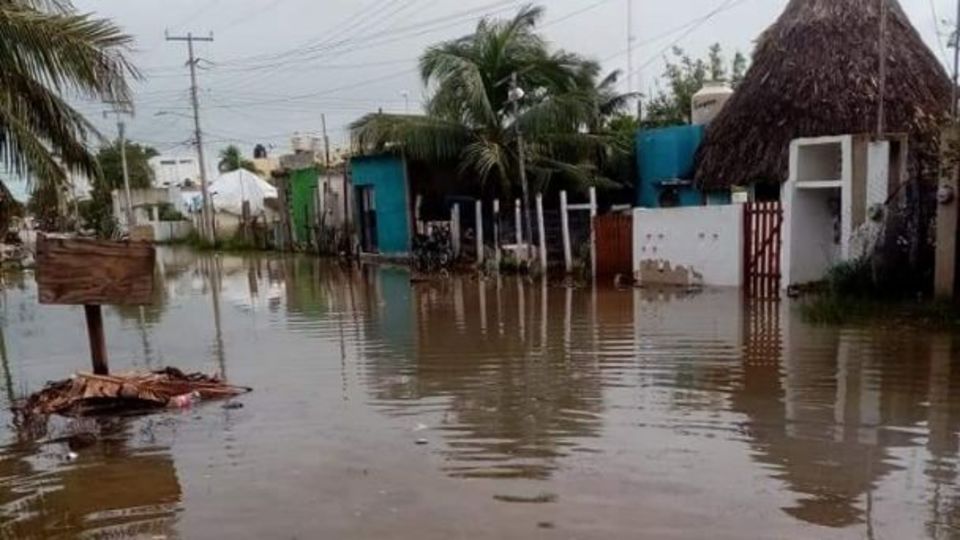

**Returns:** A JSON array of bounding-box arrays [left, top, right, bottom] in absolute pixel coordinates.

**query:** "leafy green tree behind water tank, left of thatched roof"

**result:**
[[643, 43, 747, 127]]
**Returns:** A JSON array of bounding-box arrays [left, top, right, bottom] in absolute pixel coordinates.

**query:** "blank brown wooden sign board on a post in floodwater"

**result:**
[[37, 236, 157, 375]]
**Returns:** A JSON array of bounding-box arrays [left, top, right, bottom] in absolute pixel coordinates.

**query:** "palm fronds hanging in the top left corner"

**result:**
[[0, 0, 138, 188]]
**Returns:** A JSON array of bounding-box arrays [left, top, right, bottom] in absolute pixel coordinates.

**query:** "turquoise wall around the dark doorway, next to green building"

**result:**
[[350, 155, 411, 256]]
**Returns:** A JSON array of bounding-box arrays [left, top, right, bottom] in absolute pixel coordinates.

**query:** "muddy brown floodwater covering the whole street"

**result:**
[[0, 250, 960, 540]]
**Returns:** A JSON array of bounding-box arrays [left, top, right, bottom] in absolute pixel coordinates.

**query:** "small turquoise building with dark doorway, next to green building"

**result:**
[[350, 154, 413, 257]]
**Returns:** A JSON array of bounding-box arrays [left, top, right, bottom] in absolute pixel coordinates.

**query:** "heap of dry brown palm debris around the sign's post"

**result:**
[[14, 368, 252, 417]]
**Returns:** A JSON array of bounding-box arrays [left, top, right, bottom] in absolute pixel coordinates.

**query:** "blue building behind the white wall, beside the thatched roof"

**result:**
[[636, 126, 730, 208]]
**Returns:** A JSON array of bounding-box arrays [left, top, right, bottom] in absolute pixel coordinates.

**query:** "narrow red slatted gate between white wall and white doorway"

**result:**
[[743, 201, 783, 298]]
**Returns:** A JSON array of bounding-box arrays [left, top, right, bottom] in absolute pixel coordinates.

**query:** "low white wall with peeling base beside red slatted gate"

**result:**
[[633, 204, 743, 287]]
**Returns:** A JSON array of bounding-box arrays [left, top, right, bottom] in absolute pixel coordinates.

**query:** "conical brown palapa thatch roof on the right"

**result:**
[[696, 0, 951, 188]]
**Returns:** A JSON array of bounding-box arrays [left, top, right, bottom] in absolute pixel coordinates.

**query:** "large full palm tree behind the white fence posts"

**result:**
[[351, 6, 607, 197]]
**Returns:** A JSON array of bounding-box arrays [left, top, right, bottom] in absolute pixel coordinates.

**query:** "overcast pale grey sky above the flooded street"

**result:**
[[67, 0, 956, 161]]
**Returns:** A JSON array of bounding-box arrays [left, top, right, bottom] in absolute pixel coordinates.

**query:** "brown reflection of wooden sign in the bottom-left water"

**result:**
[[0, 420, 181, 538]]
